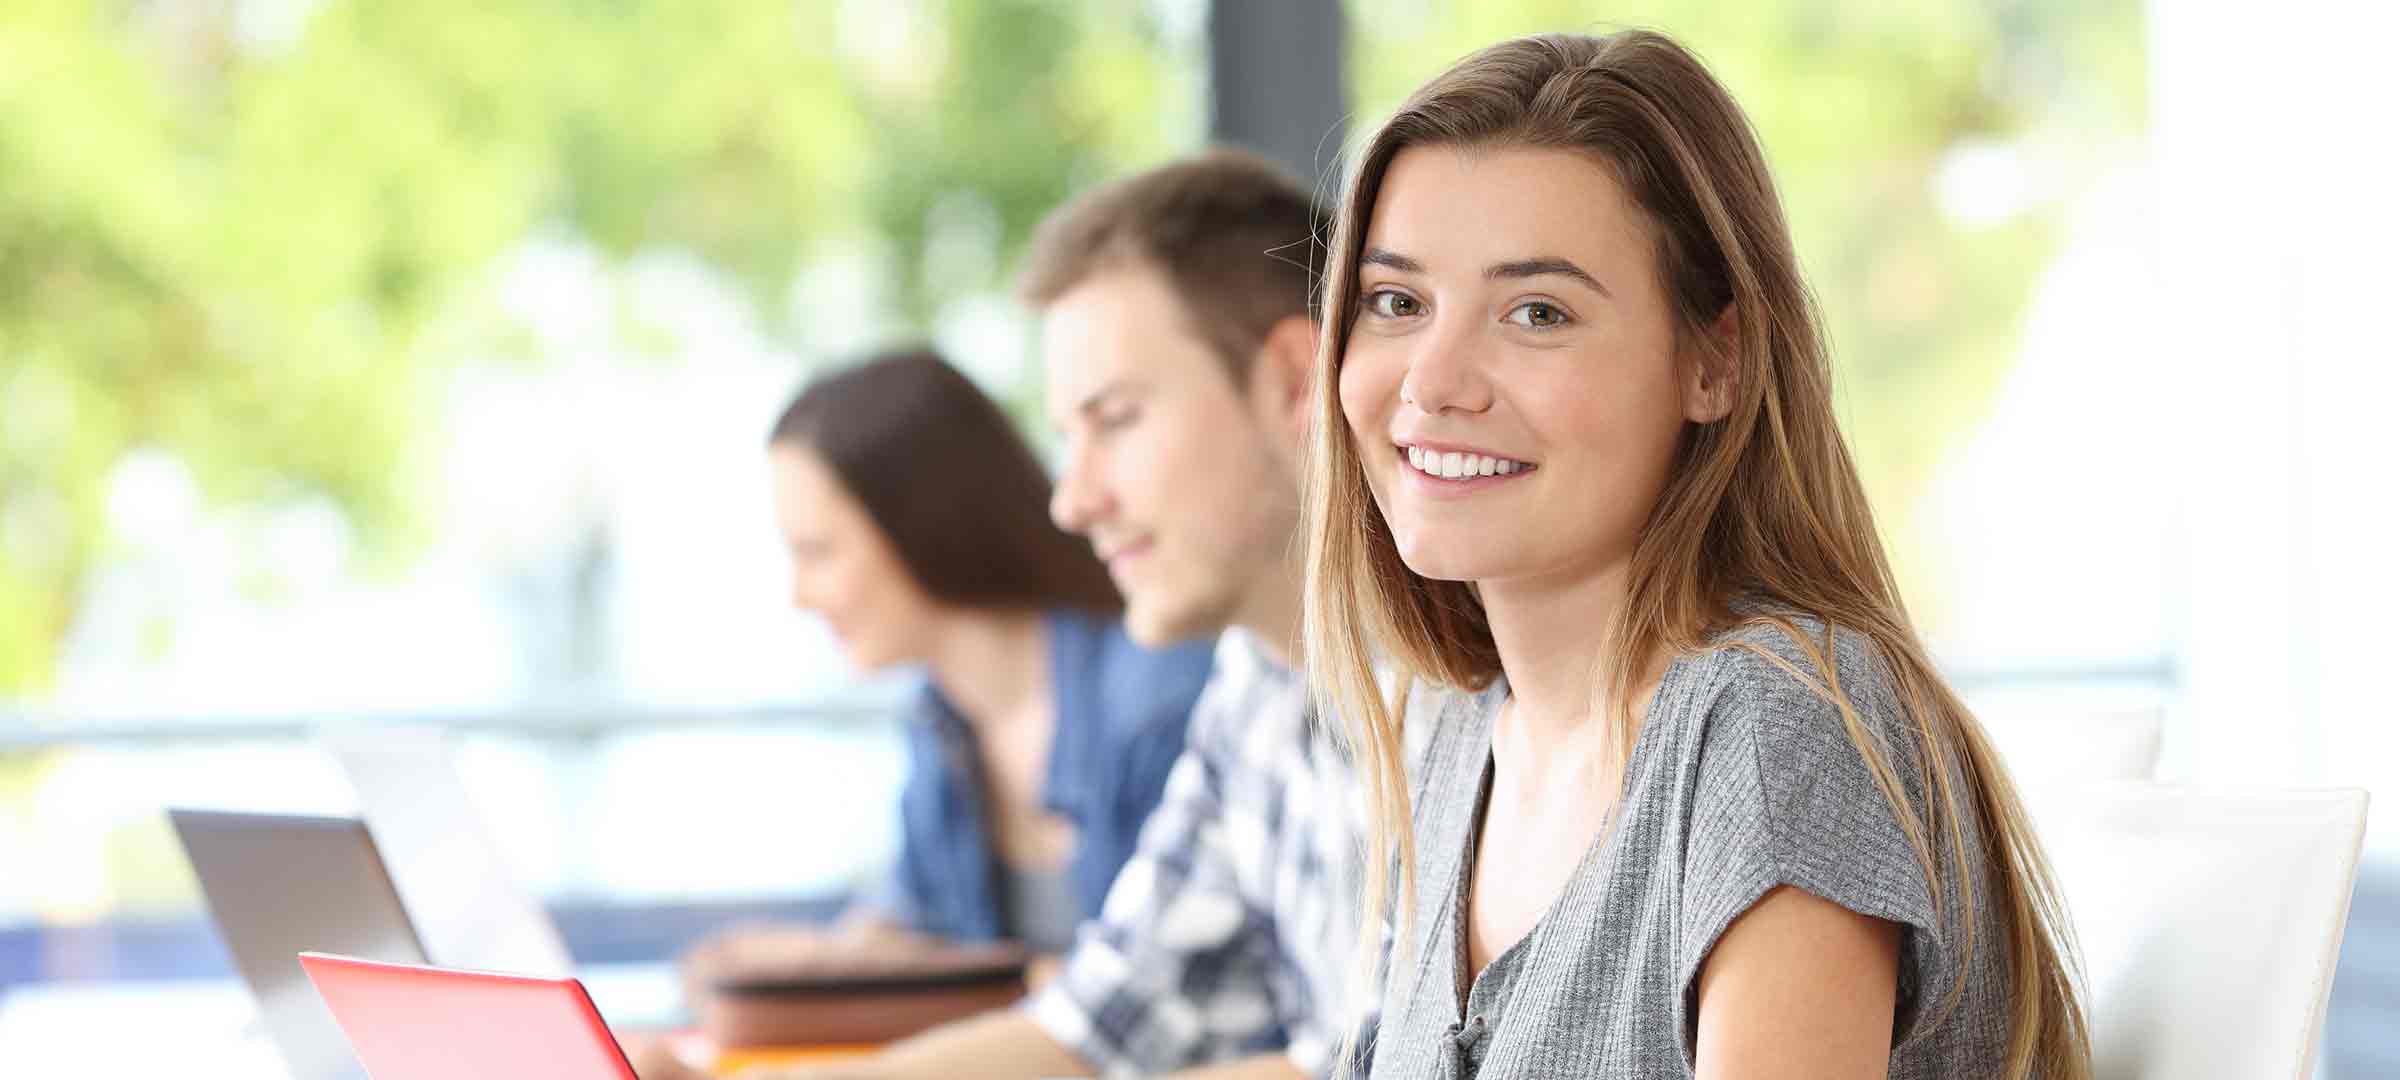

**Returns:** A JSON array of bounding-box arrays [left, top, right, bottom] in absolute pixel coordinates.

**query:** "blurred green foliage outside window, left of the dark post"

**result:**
[[0, 0, 1190, 694]]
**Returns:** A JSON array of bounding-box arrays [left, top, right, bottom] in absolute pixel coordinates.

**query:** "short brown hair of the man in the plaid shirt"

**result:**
[[1018, 149, 1330, 379]]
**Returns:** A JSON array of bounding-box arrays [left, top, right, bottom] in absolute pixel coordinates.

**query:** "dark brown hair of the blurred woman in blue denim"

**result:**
[[768, 348, 1123, 614]]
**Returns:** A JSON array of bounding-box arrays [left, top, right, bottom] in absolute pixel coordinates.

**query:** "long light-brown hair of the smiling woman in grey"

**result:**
[[1306, 31, 2090, 1080]]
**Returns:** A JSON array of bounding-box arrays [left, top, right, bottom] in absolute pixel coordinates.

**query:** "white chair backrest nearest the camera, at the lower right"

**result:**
[[2026, 782, 2366, 1080]]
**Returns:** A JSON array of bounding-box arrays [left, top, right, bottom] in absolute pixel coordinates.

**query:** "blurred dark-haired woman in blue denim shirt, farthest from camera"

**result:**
[[689, 350, 1210, 977]]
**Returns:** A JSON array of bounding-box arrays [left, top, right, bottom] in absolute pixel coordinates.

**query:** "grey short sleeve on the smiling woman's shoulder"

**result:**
[[1678, 636, 1949, 1063]]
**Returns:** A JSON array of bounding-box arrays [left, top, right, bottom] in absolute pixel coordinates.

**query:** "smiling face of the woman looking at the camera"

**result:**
[[1339, 146, 1706, 590]]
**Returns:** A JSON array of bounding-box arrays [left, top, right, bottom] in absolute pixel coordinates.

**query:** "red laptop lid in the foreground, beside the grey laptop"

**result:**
[[300, 953, 634, 1080]]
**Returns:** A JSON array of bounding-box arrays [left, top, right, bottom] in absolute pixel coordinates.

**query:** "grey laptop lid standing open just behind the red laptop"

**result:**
[[168, 809, 427, 1080]]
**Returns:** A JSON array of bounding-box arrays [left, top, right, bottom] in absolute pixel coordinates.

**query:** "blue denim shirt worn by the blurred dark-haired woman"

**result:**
[[869, 610, 1210, 941]]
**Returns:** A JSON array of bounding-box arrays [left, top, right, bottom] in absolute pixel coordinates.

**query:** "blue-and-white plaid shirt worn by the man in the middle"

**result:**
[[1025, 629, 1361, 1075]]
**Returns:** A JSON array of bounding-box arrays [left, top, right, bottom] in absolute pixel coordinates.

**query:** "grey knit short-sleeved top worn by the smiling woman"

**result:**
[[1370, 622, 2009, 1080]]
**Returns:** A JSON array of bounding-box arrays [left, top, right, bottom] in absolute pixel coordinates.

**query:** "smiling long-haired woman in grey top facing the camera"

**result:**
[[1306, 31, 2090, 1080]]
